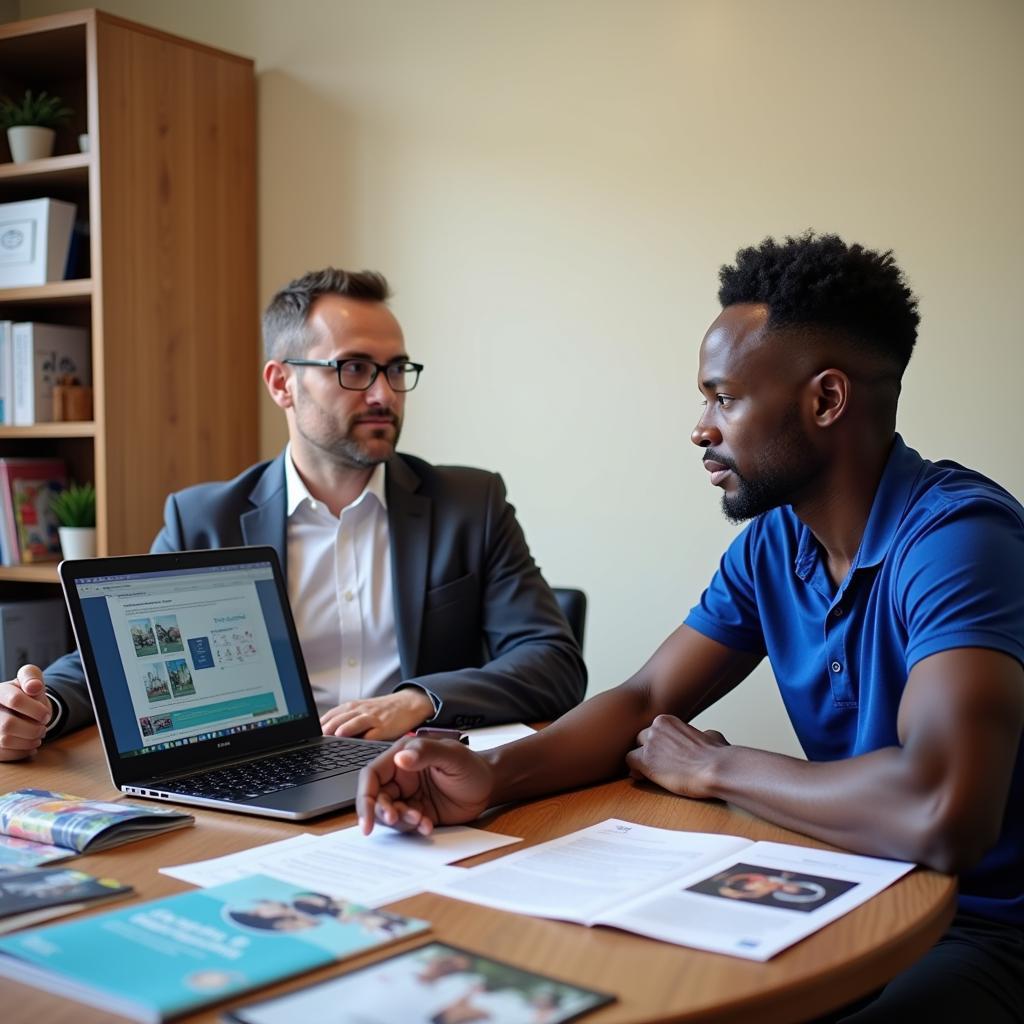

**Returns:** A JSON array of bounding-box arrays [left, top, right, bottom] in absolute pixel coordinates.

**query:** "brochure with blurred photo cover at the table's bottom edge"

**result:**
[[224, 942, 614, 1024]]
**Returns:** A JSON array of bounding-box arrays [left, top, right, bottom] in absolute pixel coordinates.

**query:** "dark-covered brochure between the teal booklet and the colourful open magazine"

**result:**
[[0, 867, 134, 935]]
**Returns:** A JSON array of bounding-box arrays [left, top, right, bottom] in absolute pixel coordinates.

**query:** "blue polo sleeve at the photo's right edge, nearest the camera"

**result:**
[[897, 500, 1024, 672]]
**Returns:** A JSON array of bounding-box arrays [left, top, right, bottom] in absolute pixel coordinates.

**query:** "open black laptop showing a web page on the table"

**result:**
[[58, 547, 390, 820]]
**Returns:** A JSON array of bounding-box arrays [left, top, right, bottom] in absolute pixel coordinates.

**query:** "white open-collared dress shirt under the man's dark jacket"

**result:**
[[285, 444, 401, 714]]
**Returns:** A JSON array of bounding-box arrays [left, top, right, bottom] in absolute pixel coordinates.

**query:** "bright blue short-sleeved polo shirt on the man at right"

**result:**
[[686, 434, 1024, 925]]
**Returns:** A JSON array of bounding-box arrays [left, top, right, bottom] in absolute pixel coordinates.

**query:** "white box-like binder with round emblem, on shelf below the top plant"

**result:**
[[0, 199, 76, 288]]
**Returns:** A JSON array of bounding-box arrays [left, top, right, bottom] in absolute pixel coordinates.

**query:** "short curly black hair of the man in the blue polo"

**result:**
[[718, 231, 921, 375]]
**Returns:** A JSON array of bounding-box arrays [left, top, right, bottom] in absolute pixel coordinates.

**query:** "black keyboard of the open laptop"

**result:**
[[168, 740, 390, 801]]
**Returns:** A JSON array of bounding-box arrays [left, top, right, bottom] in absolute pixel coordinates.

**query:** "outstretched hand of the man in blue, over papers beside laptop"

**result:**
[[355, 736, 494, 836]]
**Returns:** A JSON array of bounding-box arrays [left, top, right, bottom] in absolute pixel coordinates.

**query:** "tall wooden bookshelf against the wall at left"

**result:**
[[0, 9, 259, 600]]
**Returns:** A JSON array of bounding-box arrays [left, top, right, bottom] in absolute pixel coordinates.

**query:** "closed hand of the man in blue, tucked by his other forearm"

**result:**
[[626, 715, 729, 800]]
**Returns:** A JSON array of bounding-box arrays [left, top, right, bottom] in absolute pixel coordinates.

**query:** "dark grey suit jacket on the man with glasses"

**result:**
[[44, 455, 587, 733]]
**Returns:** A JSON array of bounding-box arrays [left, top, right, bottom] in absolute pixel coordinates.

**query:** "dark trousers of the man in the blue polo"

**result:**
[[821, 913, 1024, 1024]]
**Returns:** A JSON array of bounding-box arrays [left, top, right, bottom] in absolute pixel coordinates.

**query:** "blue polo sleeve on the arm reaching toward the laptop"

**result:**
[[686, 520, 765, 654]]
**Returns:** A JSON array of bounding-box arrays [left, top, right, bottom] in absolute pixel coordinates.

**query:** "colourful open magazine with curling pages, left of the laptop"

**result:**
[[0, 790, 196, 871]]
